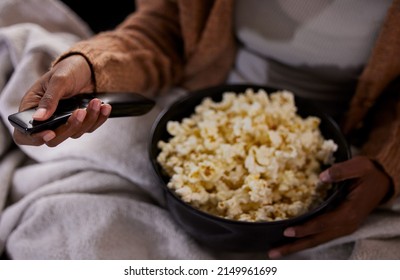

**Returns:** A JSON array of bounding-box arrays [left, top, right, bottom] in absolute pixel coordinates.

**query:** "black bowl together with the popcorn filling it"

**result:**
[[149, 85, 351, 251]]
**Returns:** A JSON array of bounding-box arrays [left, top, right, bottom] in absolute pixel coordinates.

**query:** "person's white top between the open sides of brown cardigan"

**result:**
[[229, 0, 391, 119]]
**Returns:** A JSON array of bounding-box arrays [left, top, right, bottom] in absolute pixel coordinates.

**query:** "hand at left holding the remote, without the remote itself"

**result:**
[[14, 55, 111, 147]]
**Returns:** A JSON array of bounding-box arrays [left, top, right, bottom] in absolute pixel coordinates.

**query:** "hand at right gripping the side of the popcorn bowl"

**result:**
[[268, 156, 391, 258]]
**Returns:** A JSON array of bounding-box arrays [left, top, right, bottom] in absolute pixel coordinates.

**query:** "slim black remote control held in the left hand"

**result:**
[[8, 92, 155, 134]]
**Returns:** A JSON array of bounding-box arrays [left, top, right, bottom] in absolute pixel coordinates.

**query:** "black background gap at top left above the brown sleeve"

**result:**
[[62, 0, 135, 33]]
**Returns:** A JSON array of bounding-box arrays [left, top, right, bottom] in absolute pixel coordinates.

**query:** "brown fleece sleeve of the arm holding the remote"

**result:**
[[55, 0, 184, 94]]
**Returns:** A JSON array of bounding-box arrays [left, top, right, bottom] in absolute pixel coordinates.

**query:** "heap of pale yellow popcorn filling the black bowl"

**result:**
[[157, 89, 337, 221]]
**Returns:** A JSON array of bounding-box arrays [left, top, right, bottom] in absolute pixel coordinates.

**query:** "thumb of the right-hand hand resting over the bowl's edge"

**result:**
[[319, 157, 374, 183]]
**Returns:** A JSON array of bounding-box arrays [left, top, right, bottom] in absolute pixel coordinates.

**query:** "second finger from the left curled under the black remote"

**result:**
[[46, 109, 86, 147]]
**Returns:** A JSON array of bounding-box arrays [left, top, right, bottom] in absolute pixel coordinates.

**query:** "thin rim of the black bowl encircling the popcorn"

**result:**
[[148, 83, 351, 226]]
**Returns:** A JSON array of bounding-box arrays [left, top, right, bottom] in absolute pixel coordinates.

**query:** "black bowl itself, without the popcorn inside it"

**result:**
[[149, 85, 351, 252]]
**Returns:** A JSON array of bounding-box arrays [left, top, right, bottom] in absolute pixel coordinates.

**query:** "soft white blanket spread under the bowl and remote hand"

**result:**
[[0, 0, 400, 259]]
